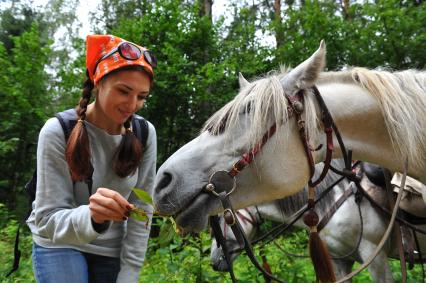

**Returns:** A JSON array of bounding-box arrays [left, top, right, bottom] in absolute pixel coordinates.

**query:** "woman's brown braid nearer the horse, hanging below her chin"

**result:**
[[113, 117, 142, 178]]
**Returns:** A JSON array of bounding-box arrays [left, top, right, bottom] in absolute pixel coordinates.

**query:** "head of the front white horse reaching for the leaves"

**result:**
[[154, 42, 325, 231]]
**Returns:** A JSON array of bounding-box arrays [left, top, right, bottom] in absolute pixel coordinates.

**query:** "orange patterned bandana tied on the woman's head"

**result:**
[[86, 34, 156, 85]]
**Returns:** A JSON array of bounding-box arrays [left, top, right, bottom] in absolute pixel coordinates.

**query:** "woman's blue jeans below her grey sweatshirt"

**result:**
[[33, 243, 120, 283]]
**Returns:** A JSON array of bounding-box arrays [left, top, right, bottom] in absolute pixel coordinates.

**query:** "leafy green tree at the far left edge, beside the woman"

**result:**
[[0, 22, 51, 205]]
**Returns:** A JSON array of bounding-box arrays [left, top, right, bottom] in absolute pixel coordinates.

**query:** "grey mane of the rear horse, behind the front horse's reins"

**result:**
[[275, 159, 349, 217]]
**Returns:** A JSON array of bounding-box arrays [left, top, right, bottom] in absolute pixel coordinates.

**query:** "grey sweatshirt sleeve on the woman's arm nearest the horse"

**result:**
[[117, 123, 157, 283]]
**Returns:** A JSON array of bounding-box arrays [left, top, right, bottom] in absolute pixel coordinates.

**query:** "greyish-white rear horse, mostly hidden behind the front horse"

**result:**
[[210, 162, 426, 283]]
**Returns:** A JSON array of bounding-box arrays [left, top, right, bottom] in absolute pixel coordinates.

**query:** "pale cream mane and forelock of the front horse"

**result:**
[[203, 68, 426, 169]]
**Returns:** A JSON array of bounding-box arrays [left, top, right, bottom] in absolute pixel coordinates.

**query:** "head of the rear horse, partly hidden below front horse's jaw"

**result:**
[[210, 207, 260, 271]]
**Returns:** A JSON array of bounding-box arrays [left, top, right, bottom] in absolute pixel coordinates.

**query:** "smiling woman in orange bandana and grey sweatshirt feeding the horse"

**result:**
[[27, 35, 157, 283]]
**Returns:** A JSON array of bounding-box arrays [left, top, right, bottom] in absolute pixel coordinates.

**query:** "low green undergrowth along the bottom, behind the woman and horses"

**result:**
[[0, 203, 422, 283]]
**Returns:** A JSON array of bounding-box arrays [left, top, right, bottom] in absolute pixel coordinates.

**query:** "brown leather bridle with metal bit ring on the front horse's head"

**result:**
[[204, 86, 355, 282]]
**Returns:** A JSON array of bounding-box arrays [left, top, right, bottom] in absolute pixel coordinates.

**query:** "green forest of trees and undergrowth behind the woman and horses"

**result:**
[[0, 0, 426, 282]]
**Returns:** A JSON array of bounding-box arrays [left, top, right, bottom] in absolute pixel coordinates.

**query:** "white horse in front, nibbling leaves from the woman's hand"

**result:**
[[153, 42, 426, 235]]
